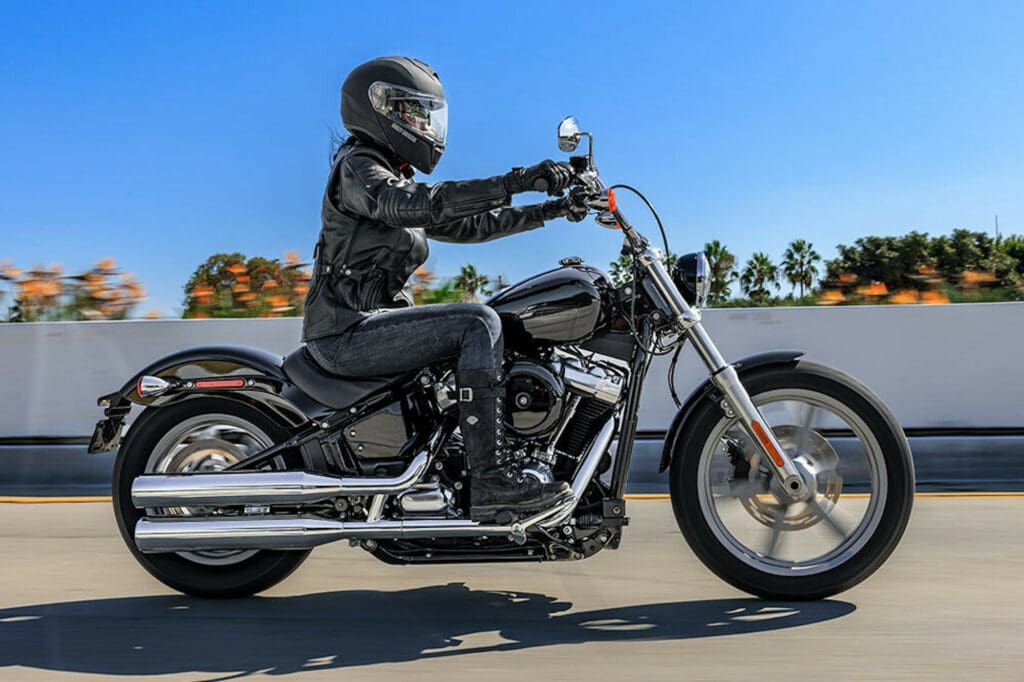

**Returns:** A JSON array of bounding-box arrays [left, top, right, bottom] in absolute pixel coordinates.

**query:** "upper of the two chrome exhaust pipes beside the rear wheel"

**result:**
[[131, 452, 430, 509]]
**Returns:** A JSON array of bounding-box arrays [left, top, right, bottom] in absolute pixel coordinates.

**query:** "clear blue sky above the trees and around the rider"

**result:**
[[0, 0, 1024, 313]]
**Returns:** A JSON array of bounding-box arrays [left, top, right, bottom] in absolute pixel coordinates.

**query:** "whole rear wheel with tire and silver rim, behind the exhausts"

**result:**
[[114, 397, 309, 597]]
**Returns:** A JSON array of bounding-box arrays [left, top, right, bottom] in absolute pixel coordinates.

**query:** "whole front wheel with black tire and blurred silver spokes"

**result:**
[[671, 361, 913, 600]]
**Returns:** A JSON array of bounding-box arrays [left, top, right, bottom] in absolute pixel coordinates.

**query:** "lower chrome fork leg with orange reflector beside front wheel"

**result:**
[[686, 323, 807, 501]]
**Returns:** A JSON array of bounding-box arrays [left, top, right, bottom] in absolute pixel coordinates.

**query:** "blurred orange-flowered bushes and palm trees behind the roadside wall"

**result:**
[[0, 223, 1024, 323]]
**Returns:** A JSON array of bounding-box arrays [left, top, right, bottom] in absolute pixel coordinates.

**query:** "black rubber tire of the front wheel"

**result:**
[[670, 361, 914, 600]]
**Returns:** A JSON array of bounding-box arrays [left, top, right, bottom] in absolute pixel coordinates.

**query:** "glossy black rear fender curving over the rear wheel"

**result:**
[[89, 346, 317, 453]]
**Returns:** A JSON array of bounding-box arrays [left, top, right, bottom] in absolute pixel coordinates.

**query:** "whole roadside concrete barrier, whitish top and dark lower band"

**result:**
[[0, 303, 1024, 491]]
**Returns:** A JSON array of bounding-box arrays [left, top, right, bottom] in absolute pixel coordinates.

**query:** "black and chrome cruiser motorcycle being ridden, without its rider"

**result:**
[[89, 117, 914, 600]]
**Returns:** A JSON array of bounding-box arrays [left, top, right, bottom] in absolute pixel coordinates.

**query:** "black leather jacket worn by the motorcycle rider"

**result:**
[[302, 138, 564, 341]]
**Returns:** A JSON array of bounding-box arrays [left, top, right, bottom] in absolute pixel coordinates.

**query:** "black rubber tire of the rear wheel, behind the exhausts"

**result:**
[[113, 397, 309, 598]]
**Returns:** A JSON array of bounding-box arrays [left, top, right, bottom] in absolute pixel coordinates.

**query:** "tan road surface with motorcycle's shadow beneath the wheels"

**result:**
[[0, 498, 1024, 682]]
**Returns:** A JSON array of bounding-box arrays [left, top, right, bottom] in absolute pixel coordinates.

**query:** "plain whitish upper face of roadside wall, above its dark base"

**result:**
[[0, 303, 1024, 437]]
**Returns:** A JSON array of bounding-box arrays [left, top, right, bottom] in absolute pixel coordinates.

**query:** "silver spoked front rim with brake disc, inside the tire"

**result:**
[[697, 389, 887, 576]]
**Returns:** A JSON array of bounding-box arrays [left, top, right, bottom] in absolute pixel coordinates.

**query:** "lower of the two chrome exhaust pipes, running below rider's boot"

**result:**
[[135, 499, 575, 553]]
